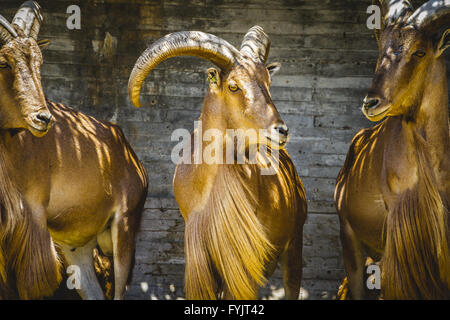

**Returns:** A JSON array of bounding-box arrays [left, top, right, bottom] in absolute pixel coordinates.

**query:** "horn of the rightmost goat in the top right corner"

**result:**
[[407, 0, 450, 29]]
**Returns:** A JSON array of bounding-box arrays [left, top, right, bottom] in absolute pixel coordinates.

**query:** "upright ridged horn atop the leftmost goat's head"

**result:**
[[12, 1, 44, 41]]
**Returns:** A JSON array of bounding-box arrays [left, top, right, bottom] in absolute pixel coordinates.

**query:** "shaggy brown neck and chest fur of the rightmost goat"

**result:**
[[381, 58, 450, 299]]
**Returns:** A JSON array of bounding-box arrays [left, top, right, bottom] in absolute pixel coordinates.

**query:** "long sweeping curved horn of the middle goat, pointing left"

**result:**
[[128, 31, 240, 107]]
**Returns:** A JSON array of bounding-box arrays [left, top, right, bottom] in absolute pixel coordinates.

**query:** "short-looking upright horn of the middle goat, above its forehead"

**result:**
[[240, 26, 270, 63]]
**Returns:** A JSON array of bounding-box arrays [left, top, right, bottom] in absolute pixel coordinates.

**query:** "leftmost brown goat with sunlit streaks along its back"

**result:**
[[0, 1, 147, 299]]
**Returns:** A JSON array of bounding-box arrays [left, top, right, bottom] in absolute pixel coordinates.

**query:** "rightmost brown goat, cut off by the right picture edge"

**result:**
[[335, 0, 450, 299]]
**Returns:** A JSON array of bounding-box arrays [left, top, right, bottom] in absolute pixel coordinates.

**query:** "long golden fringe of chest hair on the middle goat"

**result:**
[[185, 162, 274, 300]]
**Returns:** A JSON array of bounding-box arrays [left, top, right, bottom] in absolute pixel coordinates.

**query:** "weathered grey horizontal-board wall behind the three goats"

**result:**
[[0, 0, 449, 299]]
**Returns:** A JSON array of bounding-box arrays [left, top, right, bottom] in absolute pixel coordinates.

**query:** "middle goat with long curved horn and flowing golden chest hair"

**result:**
[[129, 26, 306, 299]]
